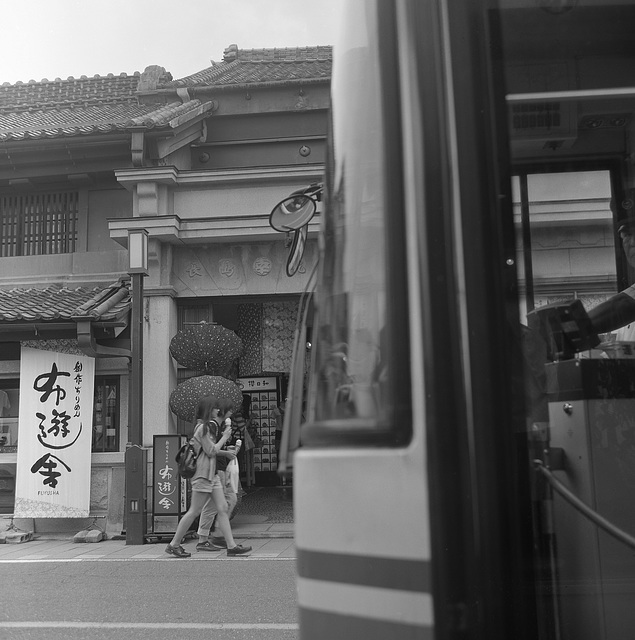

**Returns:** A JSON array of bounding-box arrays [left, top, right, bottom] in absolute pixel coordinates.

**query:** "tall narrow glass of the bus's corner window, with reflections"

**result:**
[[303, 2, 409, 445]]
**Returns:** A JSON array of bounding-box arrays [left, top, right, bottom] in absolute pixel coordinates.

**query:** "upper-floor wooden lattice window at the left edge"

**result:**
[[0, 191, 79, 258]]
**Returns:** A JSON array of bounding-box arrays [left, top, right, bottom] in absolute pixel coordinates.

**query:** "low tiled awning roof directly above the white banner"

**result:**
[[0, 282, 130, 322]]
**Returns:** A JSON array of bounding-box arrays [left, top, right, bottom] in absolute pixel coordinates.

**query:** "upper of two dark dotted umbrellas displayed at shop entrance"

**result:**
[[170, 322, 243, 375]]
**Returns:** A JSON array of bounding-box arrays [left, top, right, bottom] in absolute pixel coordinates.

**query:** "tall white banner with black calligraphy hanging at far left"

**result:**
[[14, 347, 95, 518]]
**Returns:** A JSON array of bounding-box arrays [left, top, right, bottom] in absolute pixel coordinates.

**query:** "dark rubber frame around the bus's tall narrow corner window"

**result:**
[[301, 2, 413, 447]]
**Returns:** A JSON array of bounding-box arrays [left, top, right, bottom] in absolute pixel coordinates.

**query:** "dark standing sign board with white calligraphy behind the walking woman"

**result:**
[[152, 435, 187, 533]]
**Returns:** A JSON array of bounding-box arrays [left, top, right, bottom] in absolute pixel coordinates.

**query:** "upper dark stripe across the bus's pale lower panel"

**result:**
[[297, 549, 431, 593]]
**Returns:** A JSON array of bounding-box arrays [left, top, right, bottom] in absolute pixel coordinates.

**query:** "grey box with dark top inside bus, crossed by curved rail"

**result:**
[[546, 358, 635, 640]]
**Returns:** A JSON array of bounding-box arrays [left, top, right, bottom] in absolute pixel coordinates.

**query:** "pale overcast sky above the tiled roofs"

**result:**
[[0, 0, 343, 85]]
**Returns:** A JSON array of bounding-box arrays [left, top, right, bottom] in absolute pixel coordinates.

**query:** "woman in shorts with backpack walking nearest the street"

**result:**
[[165, 396, 251, 558]]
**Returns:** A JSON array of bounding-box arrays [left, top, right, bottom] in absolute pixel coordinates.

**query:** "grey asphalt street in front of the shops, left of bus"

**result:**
[[0, 545, 298, 640]]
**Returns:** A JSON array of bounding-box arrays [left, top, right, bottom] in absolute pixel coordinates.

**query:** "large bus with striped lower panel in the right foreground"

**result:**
[[278, 0, 635, 640]]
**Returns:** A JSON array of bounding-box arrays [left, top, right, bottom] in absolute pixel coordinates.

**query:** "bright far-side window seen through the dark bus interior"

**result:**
[[512, 166, 617, 317]]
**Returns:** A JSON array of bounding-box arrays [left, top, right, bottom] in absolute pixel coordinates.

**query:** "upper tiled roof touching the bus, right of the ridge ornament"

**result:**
[[161, 45, 333, 88]]
